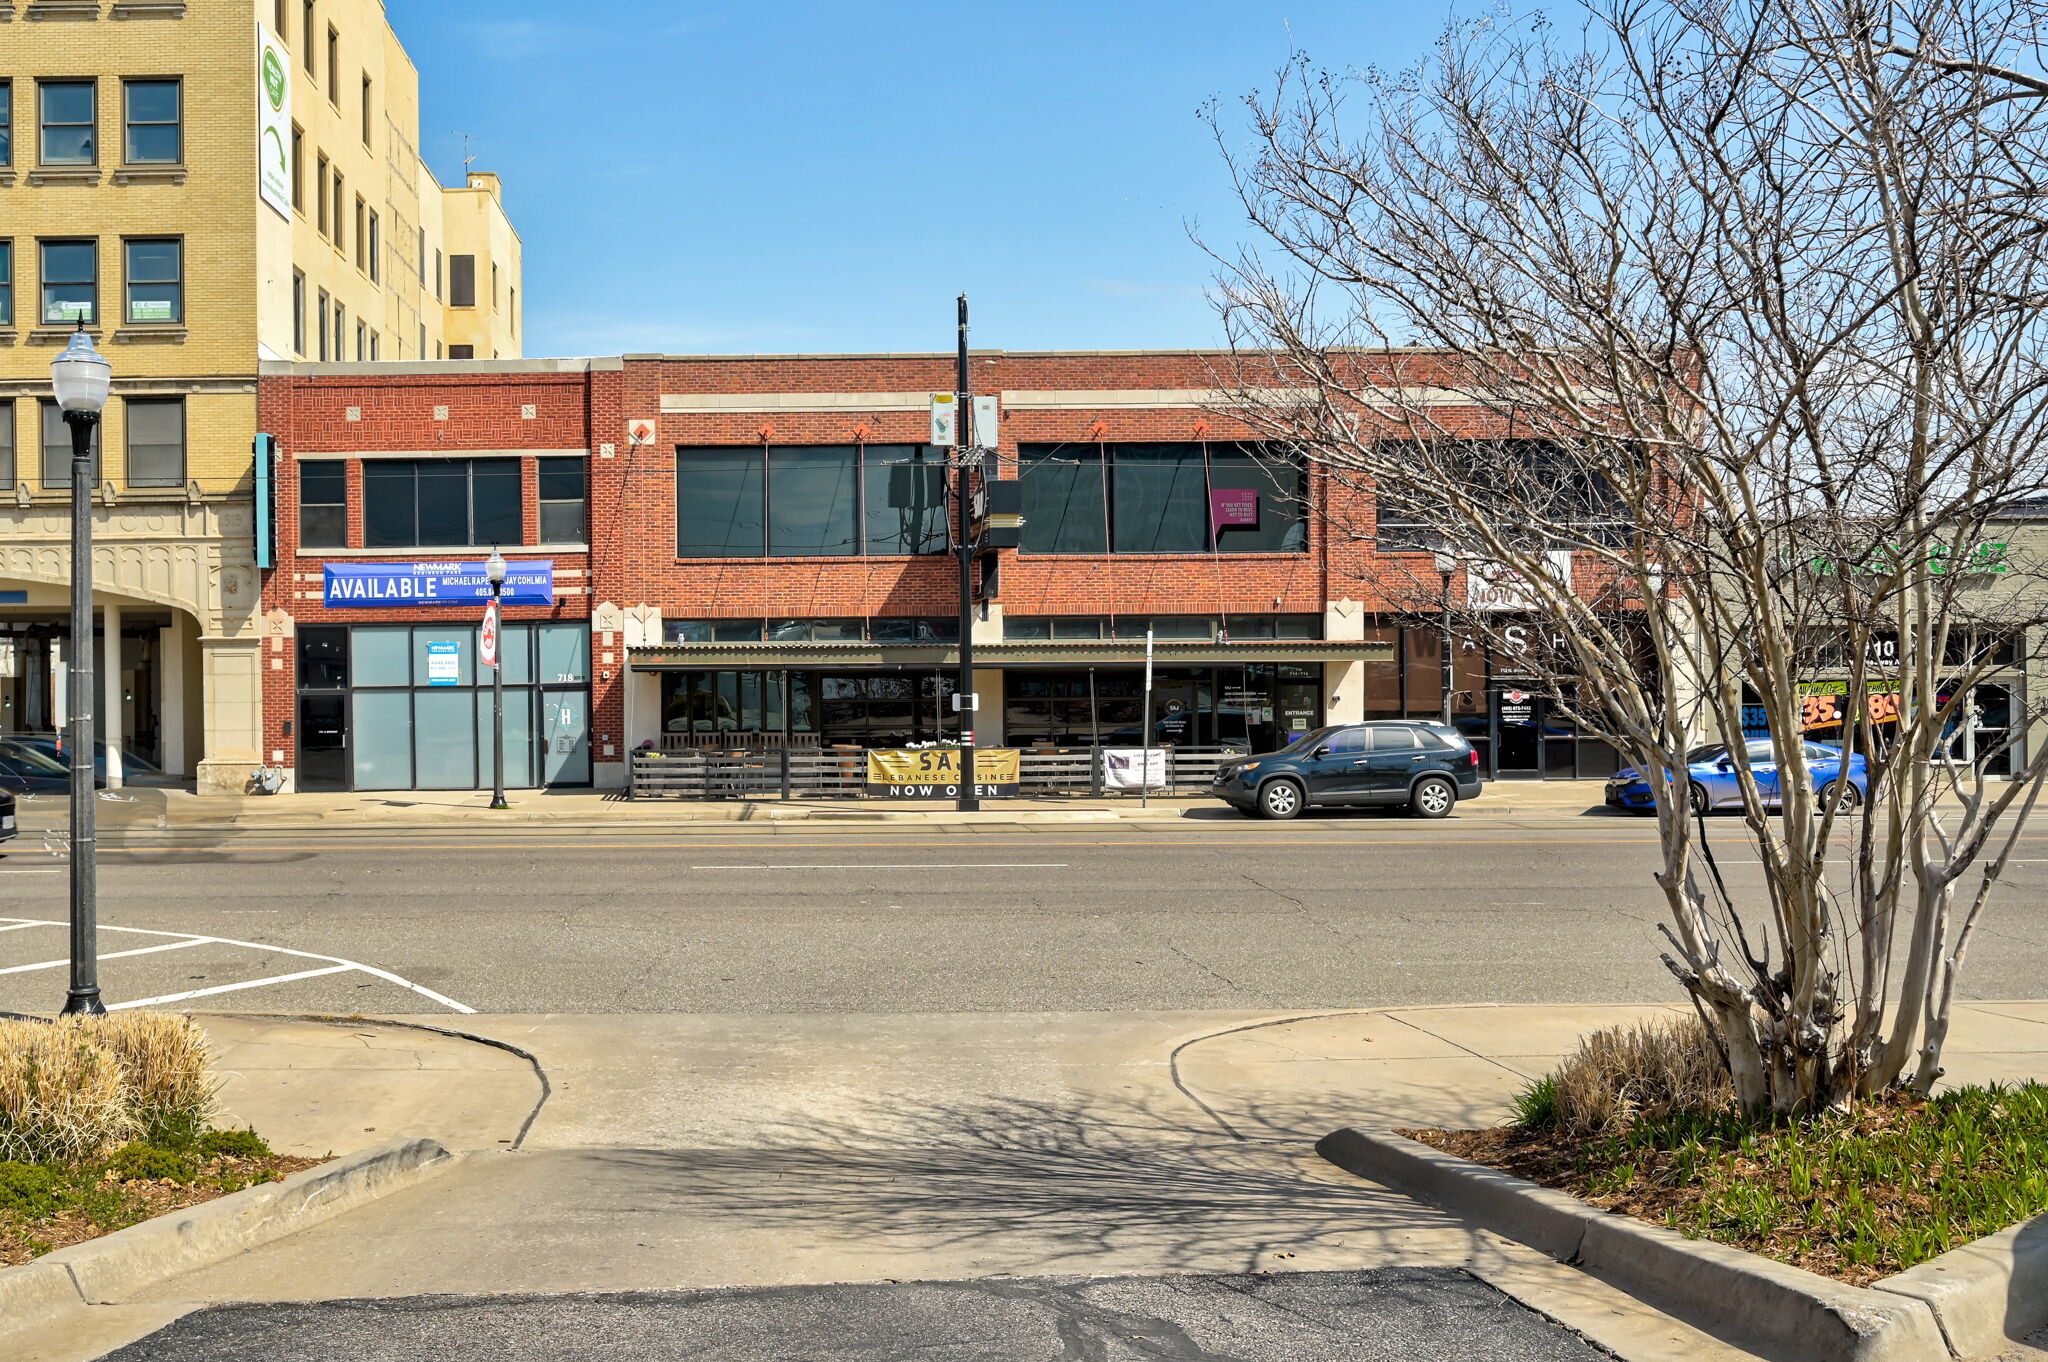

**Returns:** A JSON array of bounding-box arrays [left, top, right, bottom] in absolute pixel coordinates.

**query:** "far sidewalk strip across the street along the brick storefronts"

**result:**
[[8, 780, 1610, 834]]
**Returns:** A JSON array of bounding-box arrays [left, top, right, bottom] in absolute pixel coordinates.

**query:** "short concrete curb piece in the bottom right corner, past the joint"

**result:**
[[1872, 1215, 2048, 1358]]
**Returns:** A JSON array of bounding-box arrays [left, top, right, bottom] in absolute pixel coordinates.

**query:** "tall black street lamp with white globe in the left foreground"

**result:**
[[49, 324, 121, 1016]]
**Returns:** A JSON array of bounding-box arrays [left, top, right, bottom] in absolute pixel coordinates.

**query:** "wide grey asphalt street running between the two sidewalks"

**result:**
[[0, 813, 2048, 1014]]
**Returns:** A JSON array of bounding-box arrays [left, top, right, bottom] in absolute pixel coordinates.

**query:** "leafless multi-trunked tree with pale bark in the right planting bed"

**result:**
[[1212, 0, 2048, 1112]]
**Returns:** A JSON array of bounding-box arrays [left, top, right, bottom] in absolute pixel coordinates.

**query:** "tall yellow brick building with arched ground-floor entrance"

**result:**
[[0, 0, 522, 791]]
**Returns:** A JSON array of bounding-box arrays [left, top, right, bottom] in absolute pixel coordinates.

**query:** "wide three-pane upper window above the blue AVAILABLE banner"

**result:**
[[362, 459, 524, 549]]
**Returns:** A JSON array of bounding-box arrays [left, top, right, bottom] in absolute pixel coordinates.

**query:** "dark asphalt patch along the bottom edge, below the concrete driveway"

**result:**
[[109, 1268, 1612, 1362]]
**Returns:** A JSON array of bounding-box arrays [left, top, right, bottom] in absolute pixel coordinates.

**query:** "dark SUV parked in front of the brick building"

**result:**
[[1208, 721, 1485, 817]]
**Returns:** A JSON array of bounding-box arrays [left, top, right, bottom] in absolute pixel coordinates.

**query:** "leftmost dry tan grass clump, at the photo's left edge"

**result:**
[[0, 1022, 135, 1163]]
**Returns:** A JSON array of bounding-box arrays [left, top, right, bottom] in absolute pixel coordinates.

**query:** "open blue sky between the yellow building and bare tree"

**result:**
[[387, 0, 1448, 354]]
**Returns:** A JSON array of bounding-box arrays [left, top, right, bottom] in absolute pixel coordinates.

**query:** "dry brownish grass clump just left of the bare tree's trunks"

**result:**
[[1540, 1018, 1735, 1135]]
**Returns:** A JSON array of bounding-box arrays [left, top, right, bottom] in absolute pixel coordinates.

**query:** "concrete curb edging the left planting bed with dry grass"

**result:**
[[0, 1139, 455, 1333]]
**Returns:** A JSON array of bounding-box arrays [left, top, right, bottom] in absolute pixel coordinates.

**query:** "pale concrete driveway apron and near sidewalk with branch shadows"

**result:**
[[25, 1002, 2048, 1362]]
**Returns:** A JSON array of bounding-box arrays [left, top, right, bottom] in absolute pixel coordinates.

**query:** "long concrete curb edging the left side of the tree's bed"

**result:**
[[1315, 1129, 1950, 1362]]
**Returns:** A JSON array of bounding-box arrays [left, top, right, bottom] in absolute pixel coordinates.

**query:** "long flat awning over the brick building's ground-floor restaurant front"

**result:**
[[627, 639, 1395, 672]]
